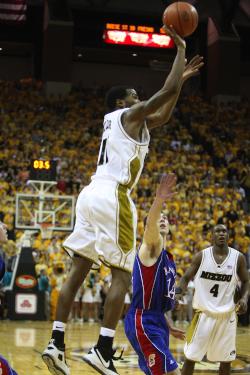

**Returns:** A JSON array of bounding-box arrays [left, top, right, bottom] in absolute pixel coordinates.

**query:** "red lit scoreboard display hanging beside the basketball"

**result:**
[[103, 23, 174, 48]]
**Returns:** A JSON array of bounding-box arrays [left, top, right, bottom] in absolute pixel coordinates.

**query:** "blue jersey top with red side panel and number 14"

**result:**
[[131, 250, 176, 313]]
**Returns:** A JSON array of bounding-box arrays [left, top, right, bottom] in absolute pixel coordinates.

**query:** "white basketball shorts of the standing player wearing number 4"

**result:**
[[184, 311, 237, 362]]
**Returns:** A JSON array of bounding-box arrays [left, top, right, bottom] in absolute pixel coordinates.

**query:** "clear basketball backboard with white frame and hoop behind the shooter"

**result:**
[[15, 180, 75, 245]]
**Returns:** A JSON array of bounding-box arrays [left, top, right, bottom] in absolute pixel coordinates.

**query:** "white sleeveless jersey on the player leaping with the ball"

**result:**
[[92, 108, 150, 189]]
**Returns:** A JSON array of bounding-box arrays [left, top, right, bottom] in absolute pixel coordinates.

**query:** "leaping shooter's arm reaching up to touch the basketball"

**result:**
[[122, 26, 186, 134]]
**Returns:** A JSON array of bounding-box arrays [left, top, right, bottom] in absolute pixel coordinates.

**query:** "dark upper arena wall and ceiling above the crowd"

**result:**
[[0, 0, 250, 95]]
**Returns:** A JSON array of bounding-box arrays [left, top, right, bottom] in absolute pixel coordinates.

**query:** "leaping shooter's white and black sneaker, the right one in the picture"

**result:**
[[82, 346, 123, 375]]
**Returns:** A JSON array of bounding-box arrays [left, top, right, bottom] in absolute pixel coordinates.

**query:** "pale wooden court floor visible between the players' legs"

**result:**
[[0, 321, 250, 375]]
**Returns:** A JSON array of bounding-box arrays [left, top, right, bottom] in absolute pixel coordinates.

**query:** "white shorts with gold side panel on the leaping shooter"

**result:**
[[63, 178, 137, 272]]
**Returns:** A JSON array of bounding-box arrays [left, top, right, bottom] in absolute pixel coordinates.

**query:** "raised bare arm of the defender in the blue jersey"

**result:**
[[140, 173, 176, 257]]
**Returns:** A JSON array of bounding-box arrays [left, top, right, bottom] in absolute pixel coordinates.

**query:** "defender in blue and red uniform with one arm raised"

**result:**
[[125, 174, 184, 375]]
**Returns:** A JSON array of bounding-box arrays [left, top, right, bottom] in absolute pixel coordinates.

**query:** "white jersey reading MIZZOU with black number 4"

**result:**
[[193, 247, 239, 314]]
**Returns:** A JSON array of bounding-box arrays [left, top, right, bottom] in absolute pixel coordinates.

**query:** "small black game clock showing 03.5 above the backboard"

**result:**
[[29, 159, 56, 181]]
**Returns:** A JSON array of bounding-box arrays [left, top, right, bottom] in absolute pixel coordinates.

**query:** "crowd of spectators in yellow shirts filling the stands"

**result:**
[[0, 79, 250, 326]]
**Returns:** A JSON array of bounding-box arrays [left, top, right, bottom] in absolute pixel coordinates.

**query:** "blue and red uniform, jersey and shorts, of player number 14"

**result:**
[[125, 250, 178, 375]]
